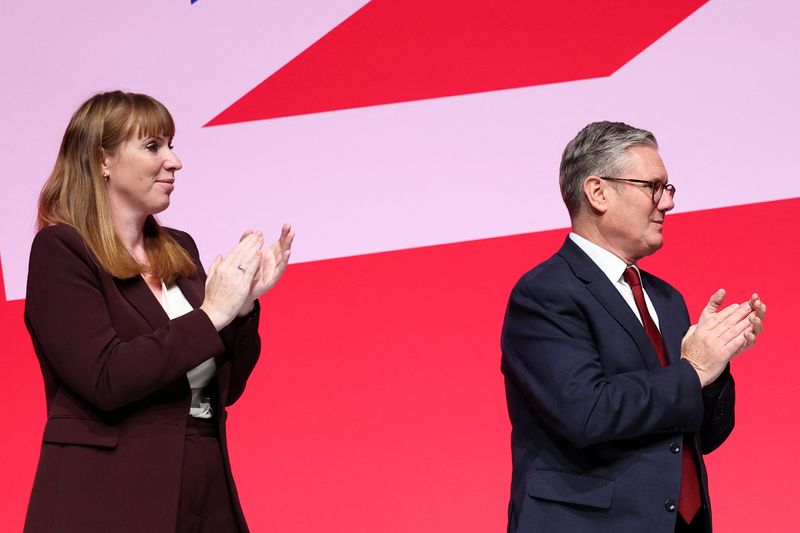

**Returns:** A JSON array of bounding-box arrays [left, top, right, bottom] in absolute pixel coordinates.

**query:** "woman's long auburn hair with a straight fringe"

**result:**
[[37, 91, 197, 285]]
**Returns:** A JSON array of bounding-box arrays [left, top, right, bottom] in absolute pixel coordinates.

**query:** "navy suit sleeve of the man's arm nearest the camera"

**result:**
[[502, 278, 703, 448]]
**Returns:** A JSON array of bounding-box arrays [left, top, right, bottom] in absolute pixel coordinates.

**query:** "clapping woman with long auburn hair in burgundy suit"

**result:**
[[25, 91, 294, 533]]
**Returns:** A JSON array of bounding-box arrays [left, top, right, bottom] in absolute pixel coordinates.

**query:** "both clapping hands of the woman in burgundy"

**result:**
[[200, 224, 294, 331]]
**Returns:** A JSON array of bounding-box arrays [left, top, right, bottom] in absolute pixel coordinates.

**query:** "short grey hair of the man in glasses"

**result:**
[[558, 121, 658, 218]]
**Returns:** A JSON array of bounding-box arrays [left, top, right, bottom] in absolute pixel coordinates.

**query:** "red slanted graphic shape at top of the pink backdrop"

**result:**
[[207, 0, 705, 126]]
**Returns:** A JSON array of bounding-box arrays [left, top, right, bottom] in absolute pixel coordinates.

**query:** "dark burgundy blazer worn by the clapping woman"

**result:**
[[25, 224, 261, 533]]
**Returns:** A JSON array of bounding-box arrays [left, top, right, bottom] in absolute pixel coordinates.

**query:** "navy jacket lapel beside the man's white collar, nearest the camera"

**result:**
[[558, 236, 661, 369]]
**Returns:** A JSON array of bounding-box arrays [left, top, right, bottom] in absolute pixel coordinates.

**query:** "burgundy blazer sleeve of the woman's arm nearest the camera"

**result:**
[[25, 226, 224, 411]]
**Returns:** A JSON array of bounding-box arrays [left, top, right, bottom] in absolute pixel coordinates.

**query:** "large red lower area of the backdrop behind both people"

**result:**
[[0, 198, 800, 533]]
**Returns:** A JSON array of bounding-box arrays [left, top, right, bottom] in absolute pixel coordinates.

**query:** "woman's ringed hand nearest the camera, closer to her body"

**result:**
[[200, 231, 264, 331]]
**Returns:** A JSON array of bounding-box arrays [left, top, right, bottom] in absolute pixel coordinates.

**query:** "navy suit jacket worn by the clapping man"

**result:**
[[501, 238, 734, 533]]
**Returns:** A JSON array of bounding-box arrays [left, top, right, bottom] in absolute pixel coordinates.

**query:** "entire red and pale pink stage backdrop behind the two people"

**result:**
[[0, 0, 800, 533]]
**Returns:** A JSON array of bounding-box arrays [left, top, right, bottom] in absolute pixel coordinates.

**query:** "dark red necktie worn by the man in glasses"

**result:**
[[623, 266, 700, 524]]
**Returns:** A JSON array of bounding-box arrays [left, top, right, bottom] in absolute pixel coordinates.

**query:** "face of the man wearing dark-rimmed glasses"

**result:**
[[603, 146, 675, 263]]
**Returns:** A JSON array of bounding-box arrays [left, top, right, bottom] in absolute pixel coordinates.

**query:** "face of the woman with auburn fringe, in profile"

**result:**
[[103, 135, 182, 219]]
